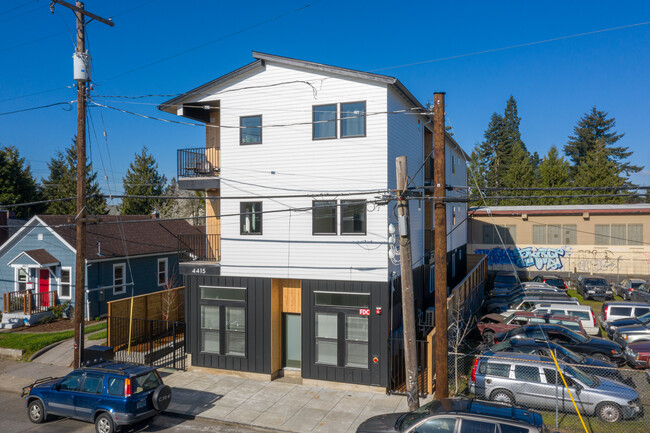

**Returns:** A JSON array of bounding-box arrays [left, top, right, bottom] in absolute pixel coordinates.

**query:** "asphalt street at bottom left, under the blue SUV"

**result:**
[[0, 392, 277, 433]]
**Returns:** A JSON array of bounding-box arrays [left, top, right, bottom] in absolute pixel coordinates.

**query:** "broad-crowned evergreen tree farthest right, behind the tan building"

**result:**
[[564, 107, 643, 176]]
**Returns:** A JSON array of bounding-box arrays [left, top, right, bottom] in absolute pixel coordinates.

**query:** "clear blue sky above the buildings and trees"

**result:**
[[0, 0, 650, 197]]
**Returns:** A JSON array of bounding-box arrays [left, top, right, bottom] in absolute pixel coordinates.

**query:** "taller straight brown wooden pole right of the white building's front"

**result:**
[[433, 93, 449, 399]]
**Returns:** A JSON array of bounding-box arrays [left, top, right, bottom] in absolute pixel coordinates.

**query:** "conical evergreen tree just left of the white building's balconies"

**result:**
[[120, 146, 167, 215]]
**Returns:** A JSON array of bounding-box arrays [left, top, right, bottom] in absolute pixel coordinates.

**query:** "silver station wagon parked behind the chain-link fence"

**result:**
[[469, 353, 643, 423]]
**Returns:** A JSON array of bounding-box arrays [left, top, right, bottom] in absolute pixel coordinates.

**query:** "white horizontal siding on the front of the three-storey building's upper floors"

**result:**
[[206, 63, 387, 281]]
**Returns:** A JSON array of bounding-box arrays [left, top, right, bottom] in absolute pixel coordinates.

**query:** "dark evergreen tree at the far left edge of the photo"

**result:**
[[0, 146, 40, 218]]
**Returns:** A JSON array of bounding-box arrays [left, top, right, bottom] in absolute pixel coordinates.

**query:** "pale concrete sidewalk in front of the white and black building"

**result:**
[[0, 360, 420, 433]]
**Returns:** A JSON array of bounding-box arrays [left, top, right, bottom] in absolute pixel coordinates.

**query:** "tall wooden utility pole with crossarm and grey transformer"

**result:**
[[50, 0, 114, 368]]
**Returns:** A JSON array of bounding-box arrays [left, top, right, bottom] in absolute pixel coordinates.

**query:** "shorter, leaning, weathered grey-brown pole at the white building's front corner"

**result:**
[[395, 156, 420, 410]]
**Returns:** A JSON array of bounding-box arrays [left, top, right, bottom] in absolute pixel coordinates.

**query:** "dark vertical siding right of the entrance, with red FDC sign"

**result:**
[[302, 280, 390, 387]]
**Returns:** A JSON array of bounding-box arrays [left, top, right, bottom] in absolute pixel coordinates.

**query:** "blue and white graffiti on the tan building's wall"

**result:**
[[475, 247, 571, 271]]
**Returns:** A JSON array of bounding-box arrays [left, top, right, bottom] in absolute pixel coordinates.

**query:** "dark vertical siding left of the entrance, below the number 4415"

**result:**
[[185, 275, 271, 374]]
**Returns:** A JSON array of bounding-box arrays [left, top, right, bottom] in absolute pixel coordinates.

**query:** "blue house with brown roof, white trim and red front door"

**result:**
[[0, 215, 204, 322]]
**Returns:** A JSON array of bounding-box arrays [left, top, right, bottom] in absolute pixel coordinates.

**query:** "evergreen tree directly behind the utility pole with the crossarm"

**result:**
[[43, 137, 106, 215]]
